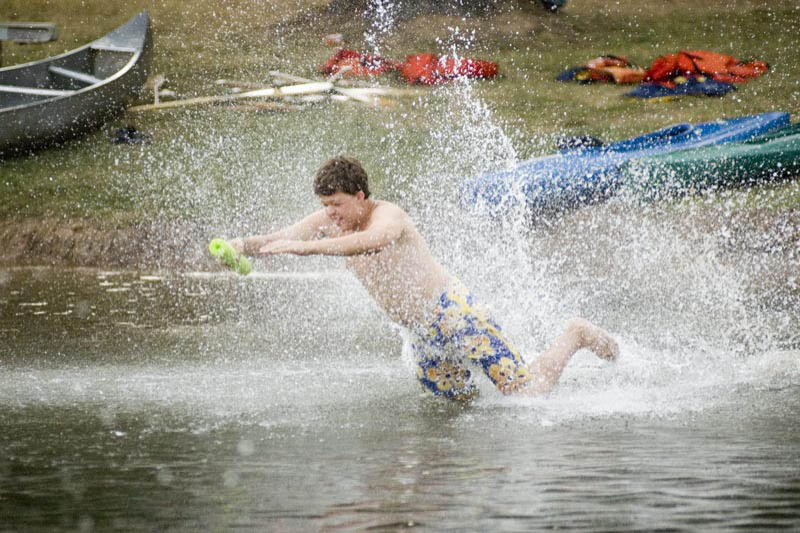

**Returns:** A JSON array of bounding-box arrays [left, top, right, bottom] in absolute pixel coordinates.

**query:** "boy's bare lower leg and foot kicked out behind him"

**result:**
[[525, 318, 619, 396]]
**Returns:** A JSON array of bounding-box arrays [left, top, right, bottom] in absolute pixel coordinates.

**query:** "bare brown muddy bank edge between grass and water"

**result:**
[[0, 205, 800, 270]]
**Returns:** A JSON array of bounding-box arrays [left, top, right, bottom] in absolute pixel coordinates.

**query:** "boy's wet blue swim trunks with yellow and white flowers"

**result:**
[[411, 282, 531, 399]]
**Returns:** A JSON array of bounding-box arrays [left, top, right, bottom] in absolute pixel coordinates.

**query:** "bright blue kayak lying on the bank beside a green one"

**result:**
[[459, 112, 789, 217]]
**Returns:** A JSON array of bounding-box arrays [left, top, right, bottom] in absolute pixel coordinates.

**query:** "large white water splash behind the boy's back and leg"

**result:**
[[370, 36, 800, 419]]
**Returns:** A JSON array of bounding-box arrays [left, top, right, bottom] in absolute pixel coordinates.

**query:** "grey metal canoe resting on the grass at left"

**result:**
[[0, 11, 150, 154]]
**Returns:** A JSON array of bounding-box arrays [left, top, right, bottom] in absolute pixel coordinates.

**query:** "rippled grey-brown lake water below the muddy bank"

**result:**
[[0, 269, 800, 531]]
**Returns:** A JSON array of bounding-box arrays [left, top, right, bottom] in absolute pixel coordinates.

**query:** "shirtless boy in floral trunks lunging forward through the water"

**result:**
[[231, 156, 619, 399]]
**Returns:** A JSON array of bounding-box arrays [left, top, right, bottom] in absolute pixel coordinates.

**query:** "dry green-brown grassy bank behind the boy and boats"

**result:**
[[0, 0, 800, 224]]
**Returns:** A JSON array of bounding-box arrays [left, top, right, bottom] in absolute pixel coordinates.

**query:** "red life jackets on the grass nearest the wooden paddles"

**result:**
[[320, 48, 497, 85]]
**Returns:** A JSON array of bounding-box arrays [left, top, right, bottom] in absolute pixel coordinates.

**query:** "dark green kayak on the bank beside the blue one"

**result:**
[[619, 123, 800, 200]]
